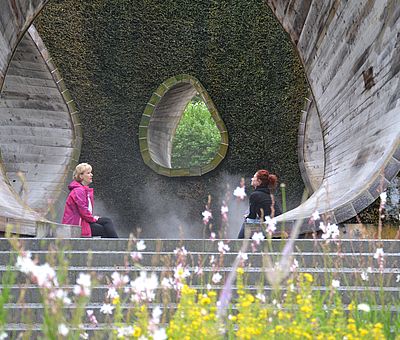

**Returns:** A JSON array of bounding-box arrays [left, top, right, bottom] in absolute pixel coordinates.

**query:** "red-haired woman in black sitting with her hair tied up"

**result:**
[[238, 169, 281, 238]]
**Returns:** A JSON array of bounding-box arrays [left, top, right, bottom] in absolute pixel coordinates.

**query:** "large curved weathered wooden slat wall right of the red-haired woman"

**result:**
[[268, 0, 400, 222]]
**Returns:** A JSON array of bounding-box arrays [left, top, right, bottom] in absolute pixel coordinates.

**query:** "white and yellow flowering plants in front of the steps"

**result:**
[[0, 235, 400, 340]]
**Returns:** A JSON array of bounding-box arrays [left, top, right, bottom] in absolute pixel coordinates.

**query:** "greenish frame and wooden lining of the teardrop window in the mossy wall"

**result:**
[[139, 75, 228, 177]]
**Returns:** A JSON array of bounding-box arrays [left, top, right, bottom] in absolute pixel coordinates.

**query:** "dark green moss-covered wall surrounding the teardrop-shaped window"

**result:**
[[35, 0, 307, 237]]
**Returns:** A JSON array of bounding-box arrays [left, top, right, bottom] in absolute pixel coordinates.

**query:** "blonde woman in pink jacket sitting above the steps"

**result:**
[[62, 163, 118, 238]]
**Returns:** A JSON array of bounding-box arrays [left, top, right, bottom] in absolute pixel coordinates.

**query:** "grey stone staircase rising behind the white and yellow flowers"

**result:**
[[0, 238, 400, 338]]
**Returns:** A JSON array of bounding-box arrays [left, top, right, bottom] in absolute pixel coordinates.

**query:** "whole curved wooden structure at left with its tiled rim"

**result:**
[[0, 1, 81, 235]]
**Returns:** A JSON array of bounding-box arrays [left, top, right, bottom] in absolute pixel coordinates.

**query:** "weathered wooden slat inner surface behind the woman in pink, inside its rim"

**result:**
[[0, 34, 74, 213]]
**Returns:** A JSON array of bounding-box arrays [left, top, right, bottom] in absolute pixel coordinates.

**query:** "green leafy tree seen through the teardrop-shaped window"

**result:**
[[171, 97, 221, 168]]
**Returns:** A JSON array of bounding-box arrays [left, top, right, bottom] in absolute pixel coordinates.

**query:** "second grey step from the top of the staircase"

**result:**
[[0, 250, 400, 268]]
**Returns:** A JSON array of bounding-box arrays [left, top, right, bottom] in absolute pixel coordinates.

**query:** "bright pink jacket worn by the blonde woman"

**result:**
[[62, 181, 96, 237]]
